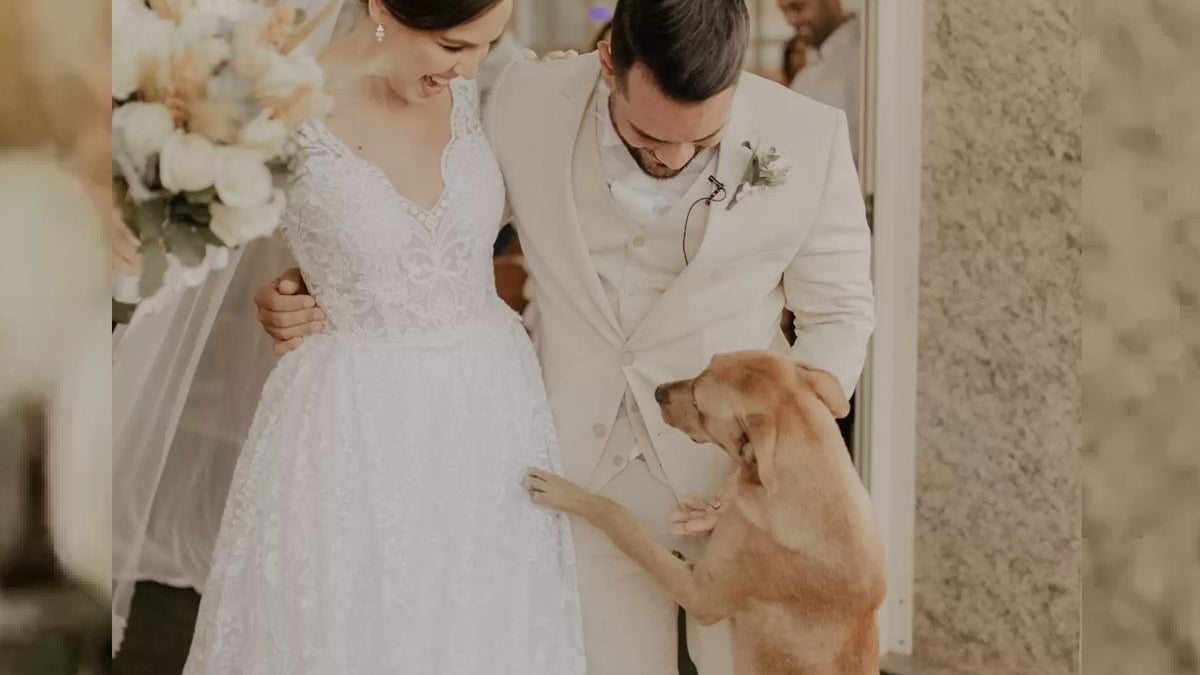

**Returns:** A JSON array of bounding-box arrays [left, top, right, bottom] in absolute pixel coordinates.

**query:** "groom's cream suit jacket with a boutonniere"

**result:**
[[485, 54, 875, 496]]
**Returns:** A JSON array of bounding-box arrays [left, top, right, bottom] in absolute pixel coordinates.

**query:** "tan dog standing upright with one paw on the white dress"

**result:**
[[526, 352, 886, 675]]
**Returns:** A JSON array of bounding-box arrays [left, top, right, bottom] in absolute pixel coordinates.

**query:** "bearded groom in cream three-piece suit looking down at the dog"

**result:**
[[257, 0, 874, 675]]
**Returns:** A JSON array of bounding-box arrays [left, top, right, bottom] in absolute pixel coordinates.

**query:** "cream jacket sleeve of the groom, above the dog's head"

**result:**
[[784, 112, 875, 398]]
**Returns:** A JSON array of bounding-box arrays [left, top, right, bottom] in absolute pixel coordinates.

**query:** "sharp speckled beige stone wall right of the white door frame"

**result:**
[[913, 0, 1082, 675]]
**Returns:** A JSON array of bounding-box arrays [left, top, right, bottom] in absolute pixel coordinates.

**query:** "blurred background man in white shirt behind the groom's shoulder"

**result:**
[[779, 0, 863, 161]]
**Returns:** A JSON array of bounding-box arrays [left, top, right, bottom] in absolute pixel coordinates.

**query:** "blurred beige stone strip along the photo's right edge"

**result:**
[[1084, 0, 1200, 675]]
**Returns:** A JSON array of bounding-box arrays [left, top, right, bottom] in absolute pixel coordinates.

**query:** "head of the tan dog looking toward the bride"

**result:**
[[654, 352, 850, 495]]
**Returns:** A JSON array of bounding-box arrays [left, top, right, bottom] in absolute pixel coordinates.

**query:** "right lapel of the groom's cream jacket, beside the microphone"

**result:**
[[629, 90, 752, 350]]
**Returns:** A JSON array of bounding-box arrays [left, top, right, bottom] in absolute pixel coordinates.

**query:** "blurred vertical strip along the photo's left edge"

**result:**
[[0, 0, 112, 675]]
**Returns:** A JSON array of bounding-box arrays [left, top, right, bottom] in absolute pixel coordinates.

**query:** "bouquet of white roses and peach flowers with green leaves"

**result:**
[[113, 0, 331, 323]]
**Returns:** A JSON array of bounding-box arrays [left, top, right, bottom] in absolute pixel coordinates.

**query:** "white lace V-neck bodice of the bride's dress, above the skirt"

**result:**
[[282, 79, 504, 339]]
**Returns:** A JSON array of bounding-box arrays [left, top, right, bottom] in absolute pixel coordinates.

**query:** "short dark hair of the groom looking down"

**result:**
[[611, 0, 750, 103]]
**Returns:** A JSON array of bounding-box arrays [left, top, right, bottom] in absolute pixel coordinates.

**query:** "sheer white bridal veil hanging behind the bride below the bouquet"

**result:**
[[113, 0, 362, 655]]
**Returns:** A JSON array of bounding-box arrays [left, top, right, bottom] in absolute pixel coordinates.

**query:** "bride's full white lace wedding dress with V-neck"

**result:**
[[185, 80, 584, 675]]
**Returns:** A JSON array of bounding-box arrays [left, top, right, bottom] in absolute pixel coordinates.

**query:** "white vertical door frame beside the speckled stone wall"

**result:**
[[854, 0, 924, 655]]
